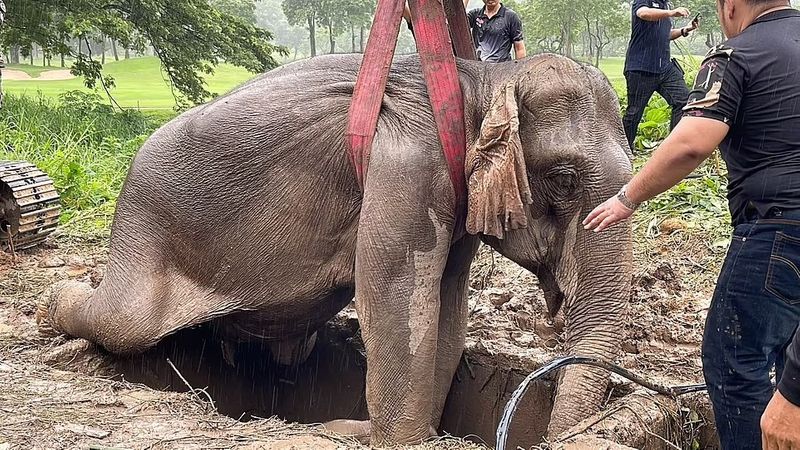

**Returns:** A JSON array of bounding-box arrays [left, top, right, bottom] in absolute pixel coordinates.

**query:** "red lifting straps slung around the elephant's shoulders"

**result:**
[[346, 0, 475, 239]]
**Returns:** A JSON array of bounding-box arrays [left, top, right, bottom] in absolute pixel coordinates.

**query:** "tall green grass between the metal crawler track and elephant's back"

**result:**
[[0, 91, 163, 230]]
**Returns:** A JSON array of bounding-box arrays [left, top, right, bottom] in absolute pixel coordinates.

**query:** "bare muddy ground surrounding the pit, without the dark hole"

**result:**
[[0, 227, 724, 450]]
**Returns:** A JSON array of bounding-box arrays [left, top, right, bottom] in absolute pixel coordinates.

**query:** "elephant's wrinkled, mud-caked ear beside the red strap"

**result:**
[[466, 82, 533, 239]]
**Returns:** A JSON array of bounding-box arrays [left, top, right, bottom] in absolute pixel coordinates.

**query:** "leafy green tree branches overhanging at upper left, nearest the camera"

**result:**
[[0, 0, 286, 103]]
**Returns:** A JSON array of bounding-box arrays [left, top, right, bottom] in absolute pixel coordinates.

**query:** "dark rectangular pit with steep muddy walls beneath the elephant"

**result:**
[[87, 314, 554, 448]]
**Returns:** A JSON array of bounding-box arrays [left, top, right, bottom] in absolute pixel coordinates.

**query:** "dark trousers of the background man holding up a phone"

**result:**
[[622, 62, 689, 150]]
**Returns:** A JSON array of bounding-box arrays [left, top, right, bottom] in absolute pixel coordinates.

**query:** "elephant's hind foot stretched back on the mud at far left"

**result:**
[[36, 280, 94, 337]]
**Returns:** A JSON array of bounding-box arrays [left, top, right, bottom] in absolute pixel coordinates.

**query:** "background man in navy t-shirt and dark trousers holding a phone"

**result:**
[[623, 0, 698, 149]]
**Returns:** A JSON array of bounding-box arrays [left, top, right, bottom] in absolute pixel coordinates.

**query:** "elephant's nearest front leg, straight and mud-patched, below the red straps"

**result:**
[[356, 153, 452, 446]]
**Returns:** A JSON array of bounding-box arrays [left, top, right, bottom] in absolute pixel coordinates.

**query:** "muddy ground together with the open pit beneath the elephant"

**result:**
[[0, 230, 717, 449]]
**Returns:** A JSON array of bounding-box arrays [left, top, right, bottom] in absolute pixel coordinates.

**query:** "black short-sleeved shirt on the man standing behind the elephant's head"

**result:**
[[467, 4, 523, 62]]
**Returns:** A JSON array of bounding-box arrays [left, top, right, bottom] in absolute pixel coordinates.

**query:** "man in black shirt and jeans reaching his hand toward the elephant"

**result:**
[[584, 0, 800, 449]]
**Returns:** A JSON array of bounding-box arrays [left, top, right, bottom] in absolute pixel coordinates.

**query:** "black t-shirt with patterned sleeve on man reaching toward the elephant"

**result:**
[[684, 9, 800, 225]]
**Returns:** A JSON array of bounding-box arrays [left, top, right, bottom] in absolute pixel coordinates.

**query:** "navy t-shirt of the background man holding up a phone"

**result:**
[[625, 0, 672, 73]]
